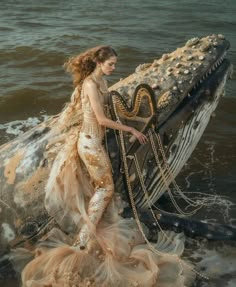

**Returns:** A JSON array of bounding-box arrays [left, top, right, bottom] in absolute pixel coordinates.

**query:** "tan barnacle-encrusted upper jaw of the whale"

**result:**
[[112, 34, 230, 129]]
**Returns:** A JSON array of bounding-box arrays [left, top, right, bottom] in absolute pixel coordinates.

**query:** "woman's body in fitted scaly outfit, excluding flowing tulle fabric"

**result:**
[[70, 46, 147, 248]]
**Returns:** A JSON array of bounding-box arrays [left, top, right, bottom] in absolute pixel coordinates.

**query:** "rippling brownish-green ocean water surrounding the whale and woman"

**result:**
[[0, 0, 236, 287]]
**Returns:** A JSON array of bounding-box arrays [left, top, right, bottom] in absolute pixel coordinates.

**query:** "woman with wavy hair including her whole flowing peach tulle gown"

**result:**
[[22, 46, 192, 287]]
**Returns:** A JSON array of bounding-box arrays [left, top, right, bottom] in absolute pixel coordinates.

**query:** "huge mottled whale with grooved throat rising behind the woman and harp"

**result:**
[[0, 34, 233, 270]]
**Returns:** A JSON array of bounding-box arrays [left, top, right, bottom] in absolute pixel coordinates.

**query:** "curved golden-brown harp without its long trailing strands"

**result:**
[[109, 84, 158, 209]]
